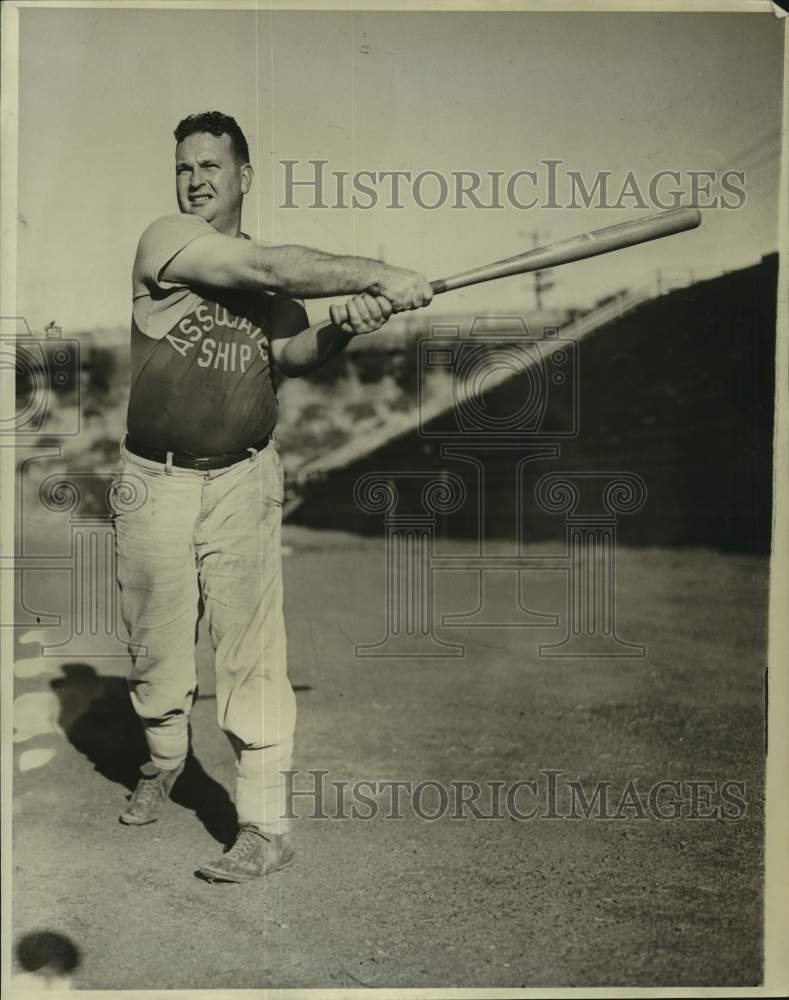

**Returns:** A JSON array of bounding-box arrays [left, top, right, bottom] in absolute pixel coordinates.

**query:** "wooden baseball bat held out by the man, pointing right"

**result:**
[[330, 208, 701, 319]]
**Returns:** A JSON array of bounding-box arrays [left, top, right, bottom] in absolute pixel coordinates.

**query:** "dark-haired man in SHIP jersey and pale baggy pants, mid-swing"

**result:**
[[114, 112, 433, 882]]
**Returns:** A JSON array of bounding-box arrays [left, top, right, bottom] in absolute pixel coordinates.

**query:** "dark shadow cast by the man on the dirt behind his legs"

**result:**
[[50, 663, 238, 847]]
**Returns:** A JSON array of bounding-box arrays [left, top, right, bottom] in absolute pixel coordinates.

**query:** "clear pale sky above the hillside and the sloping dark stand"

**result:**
[[17, 7, 783, 333]]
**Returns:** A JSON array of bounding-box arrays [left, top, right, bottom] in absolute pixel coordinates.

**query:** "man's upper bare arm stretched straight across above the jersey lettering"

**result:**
[[162, 233, 433, 312]]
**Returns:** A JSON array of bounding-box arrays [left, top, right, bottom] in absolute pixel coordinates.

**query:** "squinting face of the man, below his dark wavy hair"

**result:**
[[175, 132, 252, 235]]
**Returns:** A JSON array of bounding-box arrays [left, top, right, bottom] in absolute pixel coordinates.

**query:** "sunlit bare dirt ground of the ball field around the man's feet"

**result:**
[[13, 529, 767, 990]]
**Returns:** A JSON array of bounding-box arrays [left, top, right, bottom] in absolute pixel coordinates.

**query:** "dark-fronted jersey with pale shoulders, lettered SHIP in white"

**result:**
[[127, 215, 307, 456]]
